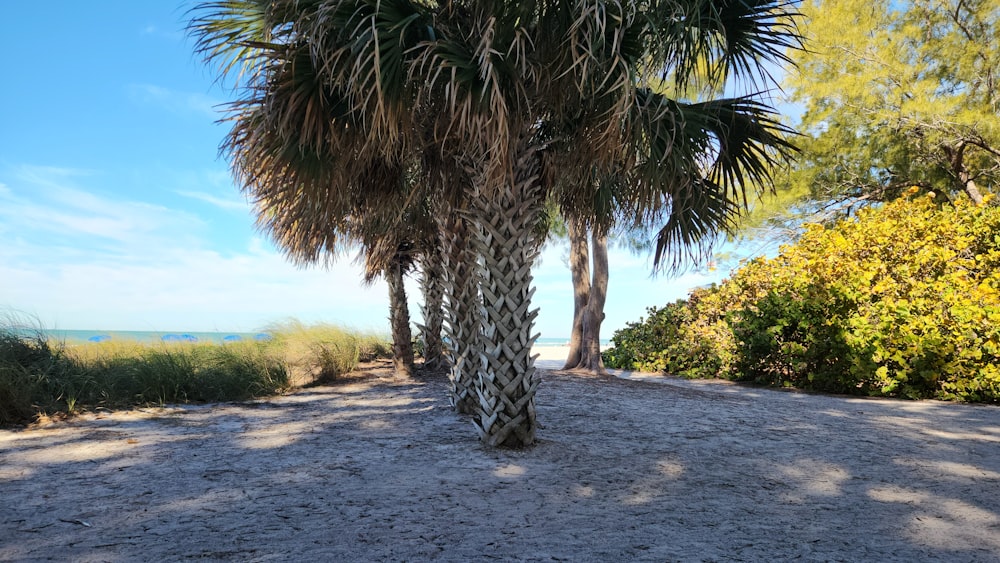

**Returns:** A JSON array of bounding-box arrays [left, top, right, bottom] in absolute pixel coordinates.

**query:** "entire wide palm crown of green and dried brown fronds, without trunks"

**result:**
[[189, 0, 800, 280]]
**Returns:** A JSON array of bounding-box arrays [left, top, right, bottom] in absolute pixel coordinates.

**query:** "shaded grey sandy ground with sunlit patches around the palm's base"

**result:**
[[0, 344, 1000, 561]]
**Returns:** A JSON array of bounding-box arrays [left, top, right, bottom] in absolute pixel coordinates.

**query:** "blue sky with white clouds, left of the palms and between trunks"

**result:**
[[0, 0, 736, 338]]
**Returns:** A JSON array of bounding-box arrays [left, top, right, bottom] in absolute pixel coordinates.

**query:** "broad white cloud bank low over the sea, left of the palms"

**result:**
[[0, 168, 388, 330]]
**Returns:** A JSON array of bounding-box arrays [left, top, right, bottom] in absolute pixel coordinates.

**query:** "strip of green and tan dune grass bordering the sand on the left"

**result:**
[[0, 321, 390, 424]]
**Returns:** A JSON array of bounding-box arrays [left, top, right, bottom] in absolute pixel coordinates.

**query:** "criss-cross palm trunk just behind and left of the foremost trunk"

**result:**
[[438, 209, 482, 414]]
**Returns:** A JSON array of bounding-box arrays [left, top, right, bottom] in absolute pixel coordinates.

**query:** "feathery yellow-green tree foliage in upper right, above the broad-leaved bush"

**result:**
[[778, 0, 1000, 207]]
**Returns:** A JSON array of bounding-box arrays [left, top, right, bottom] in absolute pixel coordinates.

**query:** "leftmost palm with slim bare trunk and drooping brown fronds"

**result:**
[[191, 1, 426, 376]]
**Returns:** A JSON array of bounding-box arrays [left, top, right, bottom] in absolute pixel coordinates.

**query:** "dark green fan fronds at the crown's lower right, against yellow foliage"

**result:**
[[622, 90, 795, 267]]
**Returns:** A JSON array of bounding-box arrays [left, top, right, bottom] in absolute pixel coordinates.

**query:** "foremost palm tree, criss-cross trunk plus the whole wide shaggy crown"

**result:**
[[192, 0, 798, 446]]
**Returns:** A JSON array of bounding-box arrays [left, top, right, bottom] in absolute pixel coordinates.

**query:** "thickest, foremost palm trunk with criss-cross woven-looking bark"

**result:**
[[471, 145, 543, 447]]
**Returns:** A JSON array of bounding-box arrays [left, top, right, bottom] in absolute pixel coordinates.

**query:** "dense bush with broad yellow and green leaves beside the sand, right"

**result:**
[[608, 194, 1000, 402]]
